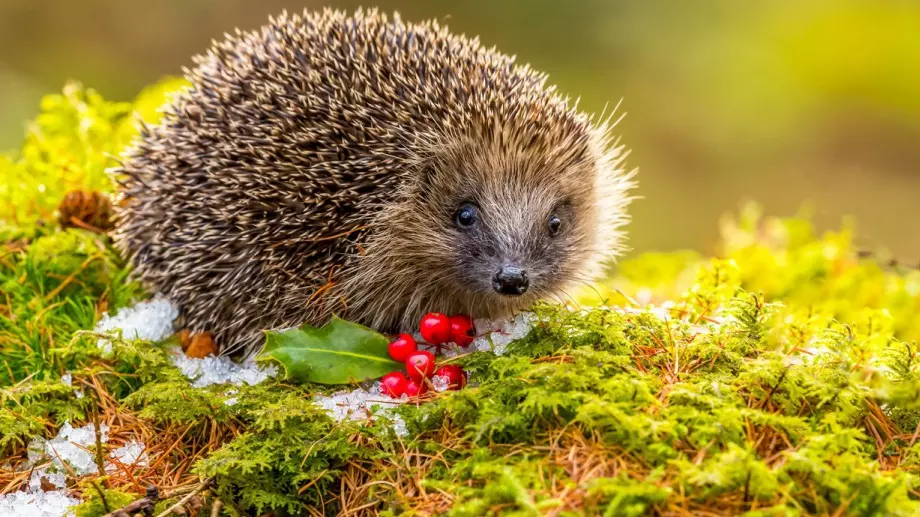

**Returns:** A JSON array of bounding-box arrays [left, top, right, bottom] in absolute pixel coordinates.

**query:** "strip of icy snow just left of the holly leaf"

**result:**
[[172, 352, 278, 388]]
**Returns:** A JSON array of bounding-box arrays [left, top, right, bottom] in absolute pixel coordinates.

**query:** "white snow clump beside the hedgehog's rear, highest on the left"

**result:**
[[96, 295, 179, 352]]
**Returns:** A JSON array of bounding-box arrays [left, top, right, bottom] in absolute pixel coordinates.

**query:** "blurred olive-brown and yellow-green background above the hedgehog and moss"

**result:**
[[0, 0, 920, 261]]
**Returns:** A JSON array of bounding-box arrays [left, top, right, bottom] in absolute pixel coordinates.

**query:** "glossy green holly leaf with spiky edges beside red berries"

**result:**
[[257, 317, 405, 384]]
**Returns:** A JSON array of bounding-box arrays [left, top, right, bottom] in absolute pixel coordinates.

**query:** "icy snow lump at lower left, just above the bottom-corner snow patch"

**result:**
[[28, 422, 109, 476]]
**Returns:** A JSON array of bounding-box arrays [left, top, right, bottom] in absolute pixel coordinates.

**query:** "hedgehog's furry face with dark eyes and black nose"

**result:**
[[398, 128, 598, 315]]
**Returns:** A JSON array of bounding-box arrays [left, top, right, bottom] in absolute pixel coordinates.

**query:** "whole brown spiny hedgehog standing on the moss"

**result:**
[[113, 10, 634, 357]]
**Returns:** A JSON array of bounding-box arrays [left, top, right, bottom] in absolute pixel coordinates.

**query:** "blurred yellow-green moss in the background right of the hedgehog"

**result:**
[[581, 205, 920, 341]]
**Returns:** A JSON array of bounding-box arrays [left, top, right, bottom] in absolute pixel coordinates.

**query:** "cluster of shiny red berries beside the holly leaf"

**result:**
[[380, 312, 476, 398]]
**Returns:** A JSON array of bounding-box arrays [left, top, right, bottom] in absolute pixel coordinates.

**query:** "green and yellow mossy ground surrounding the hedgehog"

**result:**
[[0, 83, 920, 516]]
